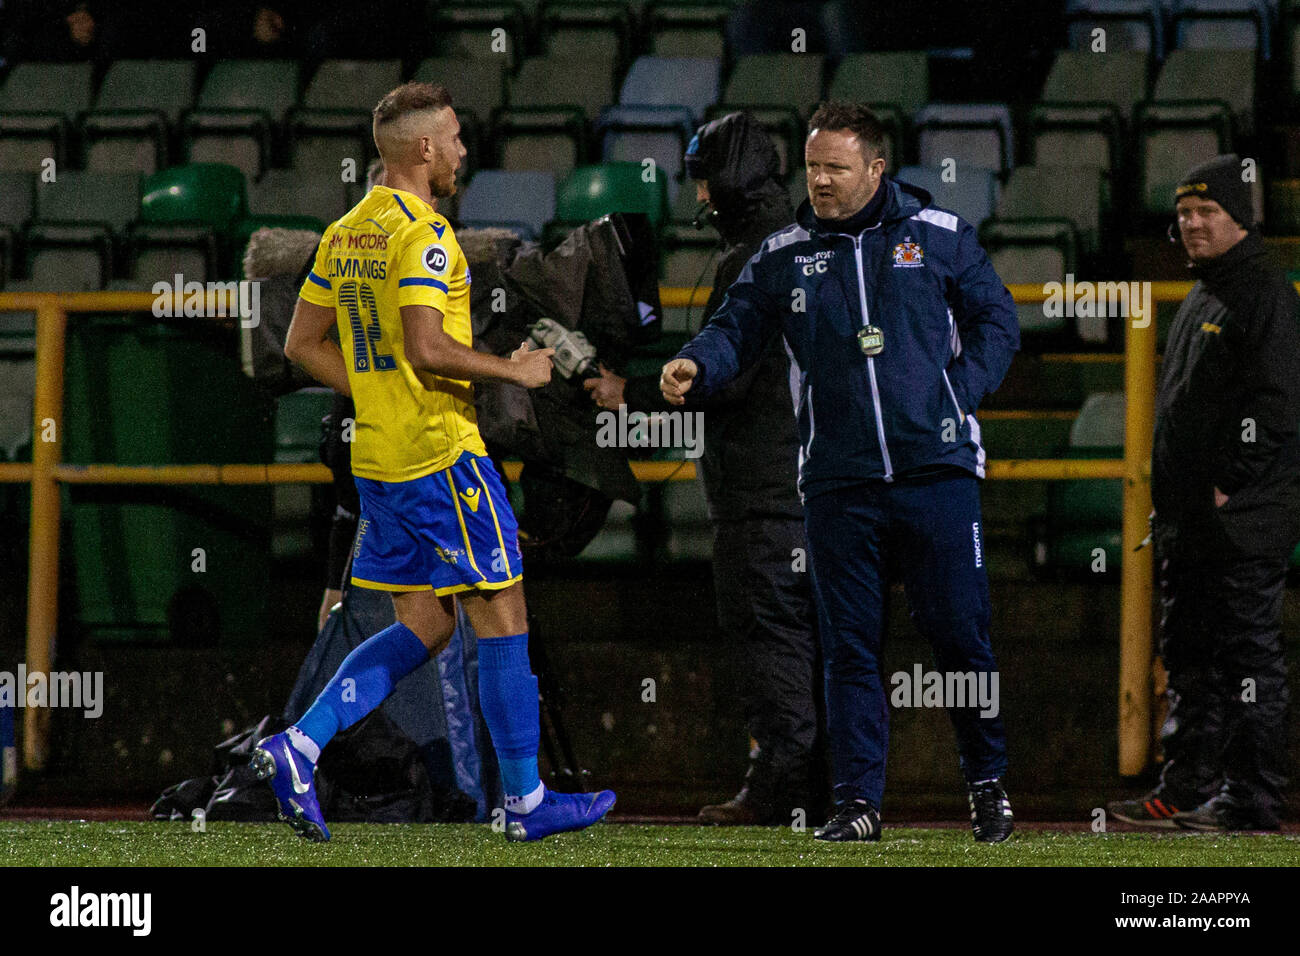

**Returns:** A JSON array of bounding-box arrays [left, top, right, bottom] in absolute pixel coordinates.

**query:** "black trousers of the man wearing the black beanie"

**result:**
[[1157, 545, 1287, 826]]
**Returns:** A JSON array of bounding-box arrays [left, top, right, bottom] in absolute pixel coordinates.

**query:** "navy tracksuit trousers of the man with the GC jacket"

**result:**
[[805, 472, 1006, 809]]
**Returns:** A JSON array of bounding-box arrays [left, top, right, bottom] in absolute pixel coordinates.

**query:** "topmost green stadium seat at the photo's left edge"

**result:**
[[0, 62, 94, 172]]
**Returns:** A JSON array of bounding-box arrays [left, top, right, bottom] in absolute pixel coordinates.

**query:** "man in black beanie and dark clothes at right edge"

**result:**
[[1110, 155, 1300, 830]]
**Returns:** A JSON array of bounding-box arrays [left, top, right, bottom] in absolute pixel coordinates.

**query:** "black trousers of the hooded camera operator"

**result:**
[[714, 518, 818, 822]]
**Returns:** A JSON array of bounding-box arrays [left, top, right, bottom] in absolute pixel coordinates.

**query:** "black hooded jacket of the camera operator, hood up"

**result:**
[[624, 113, 803, 520]]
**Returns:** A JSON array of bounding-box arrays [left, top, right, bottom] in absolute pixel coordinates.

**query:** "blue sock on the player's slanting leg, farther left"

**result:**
[[295, 620, 429, 749]]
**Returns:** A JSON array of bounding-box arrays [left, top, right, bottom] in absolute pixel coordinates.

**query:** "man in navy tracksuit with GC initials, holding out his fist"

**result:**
[[660, 103, 1019, 842]]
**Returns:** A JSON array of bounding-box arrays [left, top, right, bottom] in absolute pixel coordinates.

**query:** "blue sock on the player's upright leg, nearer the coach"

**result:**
[[478, 631, 542, 799]]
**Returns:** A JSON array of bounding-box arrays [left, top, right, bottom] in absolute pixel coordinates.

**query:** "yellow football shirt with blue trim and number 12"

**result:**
[[300, 186, 488, 481]]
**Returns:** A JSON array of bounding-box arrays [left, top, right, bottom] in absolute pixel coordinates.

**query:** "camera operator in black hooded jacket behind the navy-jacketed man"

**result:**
[[584, 113, 820, 825]]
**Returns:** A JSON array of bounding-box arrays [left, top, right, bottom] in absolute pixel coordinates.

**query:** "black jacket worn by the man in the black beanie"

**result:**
[[1152, 229, 1300, 557]]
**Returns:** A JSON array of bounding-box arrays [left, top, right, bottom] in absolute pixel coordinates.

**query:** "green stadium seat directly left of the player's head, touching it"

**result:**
[[289, 60, 402, 170]]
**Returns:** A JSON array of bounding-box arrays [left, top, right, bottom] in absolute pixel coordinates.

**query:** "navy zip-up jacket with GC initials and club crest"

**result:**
[[679, 177, 1019, 501]]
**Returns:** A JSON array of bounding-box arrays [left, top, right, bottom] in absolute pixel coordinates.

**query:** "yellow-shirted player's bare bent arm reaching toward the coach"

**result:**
[[400, 306, 555, 389]]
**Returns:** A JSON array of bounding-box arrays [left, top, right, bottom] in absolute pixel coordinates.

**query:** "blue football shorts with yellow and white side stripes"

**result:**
[[352, 453, 524, 596]]
